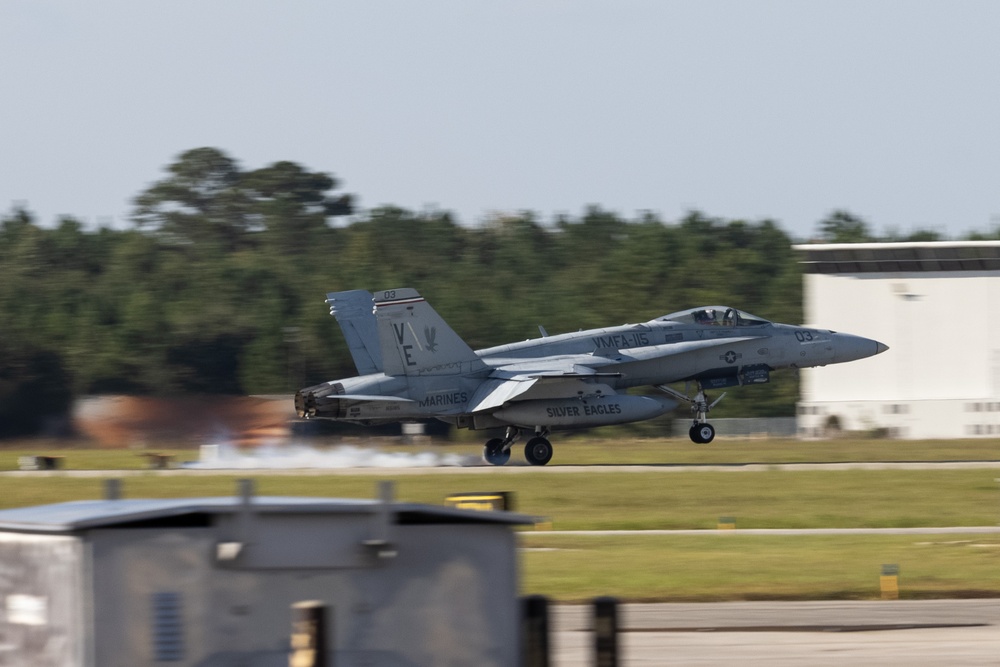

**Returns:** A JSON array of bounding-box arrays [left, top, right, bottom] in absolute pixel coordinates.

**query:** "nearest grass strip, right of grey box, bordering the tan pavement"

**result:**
[[522, 531, 1000, 602]]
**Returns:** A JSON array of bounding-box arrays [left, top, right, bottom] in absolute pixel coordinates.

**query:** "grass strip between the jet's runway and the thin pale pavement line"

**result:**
[[0, 469, 1000, 530]]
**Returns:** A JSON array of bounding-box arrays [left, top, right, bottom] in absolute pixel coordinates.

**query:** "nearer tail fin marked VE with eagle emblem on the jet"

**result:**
[[375, 288, 486, 375]]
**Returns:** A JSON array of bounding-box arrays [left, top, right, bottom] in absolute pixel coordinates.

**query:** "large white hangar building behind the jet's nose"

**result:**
[[795, 241, 1000, 439]]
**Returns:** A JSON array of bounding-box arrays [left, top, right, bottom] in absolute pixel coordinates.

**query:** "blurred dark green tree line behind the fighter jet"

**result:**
[[0, 148, 984, 435]]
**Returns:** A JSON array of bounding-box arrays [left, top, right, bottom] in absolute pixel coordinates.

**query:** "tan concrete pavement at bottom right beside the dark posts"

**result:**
[[550, 599, 1000, 667]]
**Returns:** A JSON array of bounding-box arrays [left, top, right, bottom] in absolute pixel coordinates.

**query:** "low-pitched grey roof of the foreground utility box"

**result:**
[[0, 496, 535, 533]]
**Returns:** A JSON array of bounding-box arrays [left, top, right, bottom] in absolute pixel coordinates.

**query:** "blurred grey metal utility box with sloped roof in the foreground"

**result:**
[[0, 486, 530, 667]]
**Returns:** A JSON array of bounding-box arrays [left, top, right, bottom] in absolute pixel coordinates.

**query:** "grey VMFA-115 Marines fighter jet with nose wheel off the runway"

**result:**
[[295, 288, 888, 465]]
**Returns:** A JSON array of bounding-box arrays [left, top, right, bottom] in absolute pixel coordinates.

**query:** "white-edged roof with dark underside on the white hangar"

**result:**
[[792, 241, 1000, 273]]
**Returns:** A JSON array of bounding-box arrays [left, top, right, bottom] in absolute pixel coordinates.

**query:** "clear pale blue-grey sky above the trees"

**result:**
[[0, 0, 1000, 239]]
